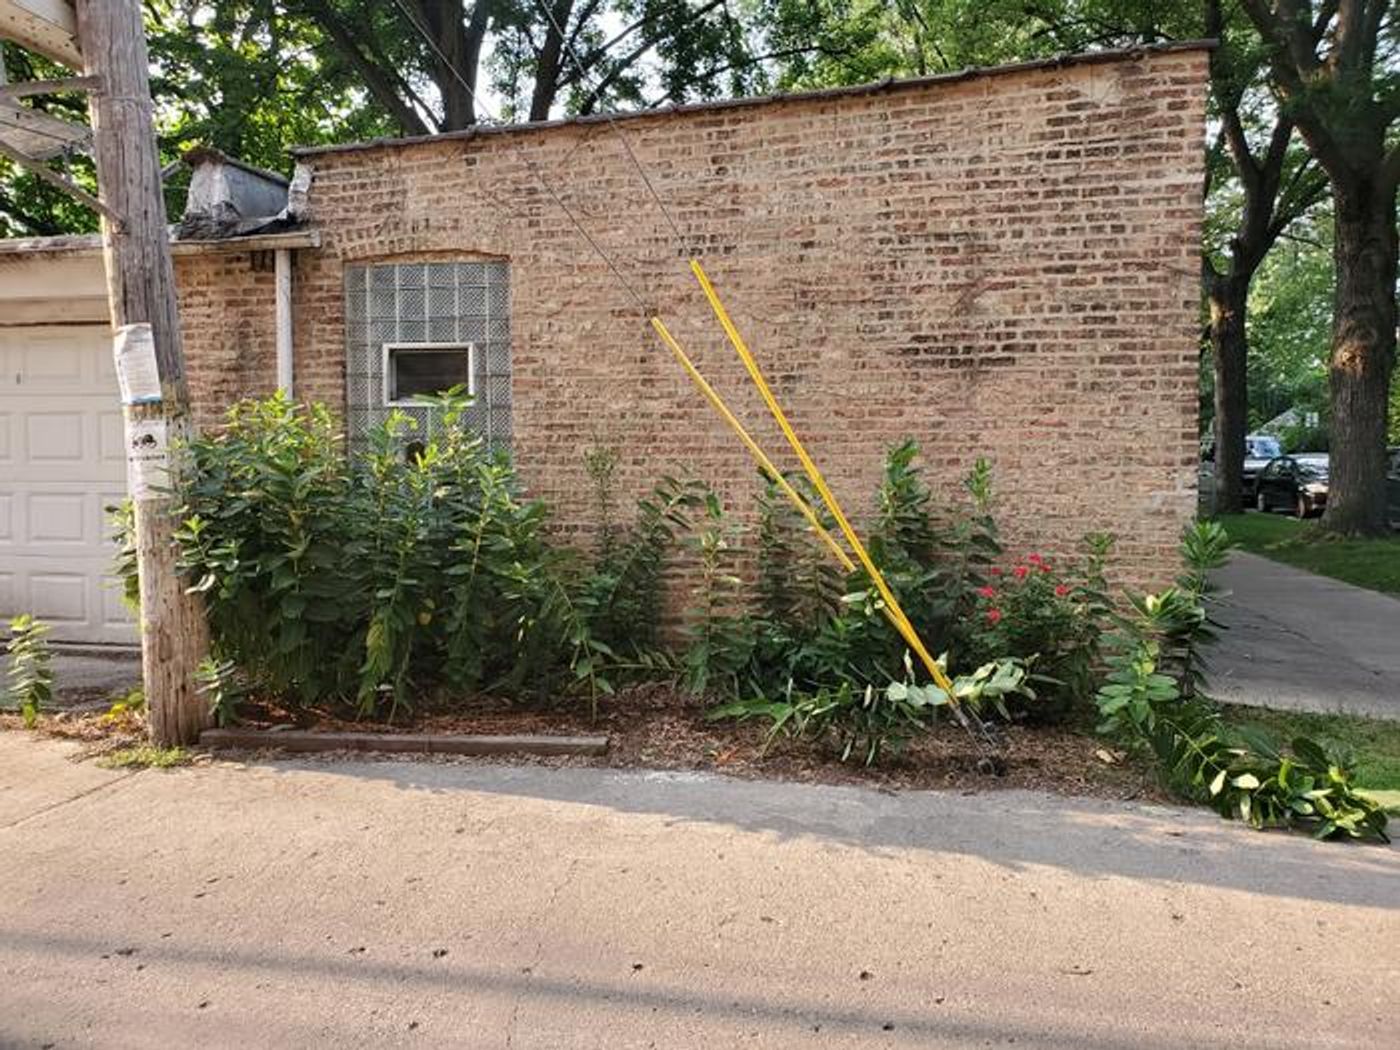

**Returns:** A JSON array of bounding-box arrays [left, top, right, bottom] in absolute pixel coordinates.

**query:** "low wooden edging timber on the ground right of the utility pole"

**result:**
[[199, 728, 608, 755]]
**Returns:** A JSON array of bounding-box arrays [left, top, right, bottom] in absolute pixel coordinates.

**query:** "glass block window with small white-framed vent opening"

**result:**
[[346, 262, 511, 448]]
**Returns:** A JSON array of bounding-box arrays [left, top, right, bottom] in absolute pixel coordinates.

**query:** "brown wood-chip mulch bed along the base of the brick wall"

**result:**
[[0, 685, 1165, 799]]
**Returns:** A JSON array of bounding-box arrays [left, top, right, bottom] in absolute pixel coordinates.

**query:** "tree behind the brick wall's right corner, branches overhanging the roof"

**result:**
[[770, 0, 1326, 510]]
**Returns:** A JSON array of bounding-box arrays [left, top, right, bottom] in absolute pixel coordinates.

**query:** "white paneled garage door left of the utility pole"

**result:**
[[0, 325, 136, 644]]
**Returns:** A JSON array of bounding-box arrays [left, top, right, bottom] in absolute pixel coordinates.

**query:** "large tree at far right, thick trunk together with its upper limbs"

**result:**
[[1242, 0, 1400, 533]]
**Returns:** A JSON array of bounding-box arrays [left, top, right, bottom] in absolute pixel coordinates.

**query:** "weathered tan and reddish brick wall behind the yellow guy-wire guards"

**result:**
[[182, 49, 1207, 584]]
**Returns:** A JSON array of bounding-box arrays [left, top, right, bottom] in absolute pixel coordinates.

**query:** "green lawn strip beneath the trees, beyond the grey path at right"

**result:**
[[1219, 514, 1400, 595]]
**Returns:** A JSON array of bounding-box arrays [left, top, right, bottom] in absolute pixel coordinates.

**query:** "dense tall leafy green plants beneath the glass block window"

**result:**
[[162, 391, 701, 718]]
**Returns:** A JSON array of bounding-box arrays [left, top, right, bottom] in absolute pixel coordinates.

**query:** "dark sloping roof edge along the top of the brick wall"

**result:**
[[290, 39, 1219, 158]]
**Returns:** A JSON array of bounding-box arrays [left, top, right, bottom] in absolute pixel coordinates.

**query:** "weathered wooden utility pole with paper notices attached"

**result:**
[[77, 0, 210, 746]]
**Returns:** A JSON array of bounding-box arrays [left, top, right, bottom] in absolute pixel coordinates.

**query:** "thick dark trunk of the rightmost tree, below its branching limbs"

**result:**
[[1323, 180, 1397, 535]]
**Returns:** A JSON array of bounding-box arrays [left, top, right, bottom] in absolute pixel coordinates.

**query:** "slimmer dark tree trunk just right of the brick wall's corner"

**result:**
[[1205, 276, 1249, 514]]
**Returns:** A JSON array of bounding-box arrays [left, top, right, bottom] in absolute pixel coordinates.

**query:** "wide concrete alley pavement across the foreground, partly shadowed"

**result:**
[[0, 734, 1400, 1050]]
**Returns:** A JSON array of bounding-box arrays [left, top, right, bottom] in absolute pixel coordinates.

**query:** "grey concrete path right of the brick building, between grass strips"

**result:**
[[1210, 550, 1400, 718]]
